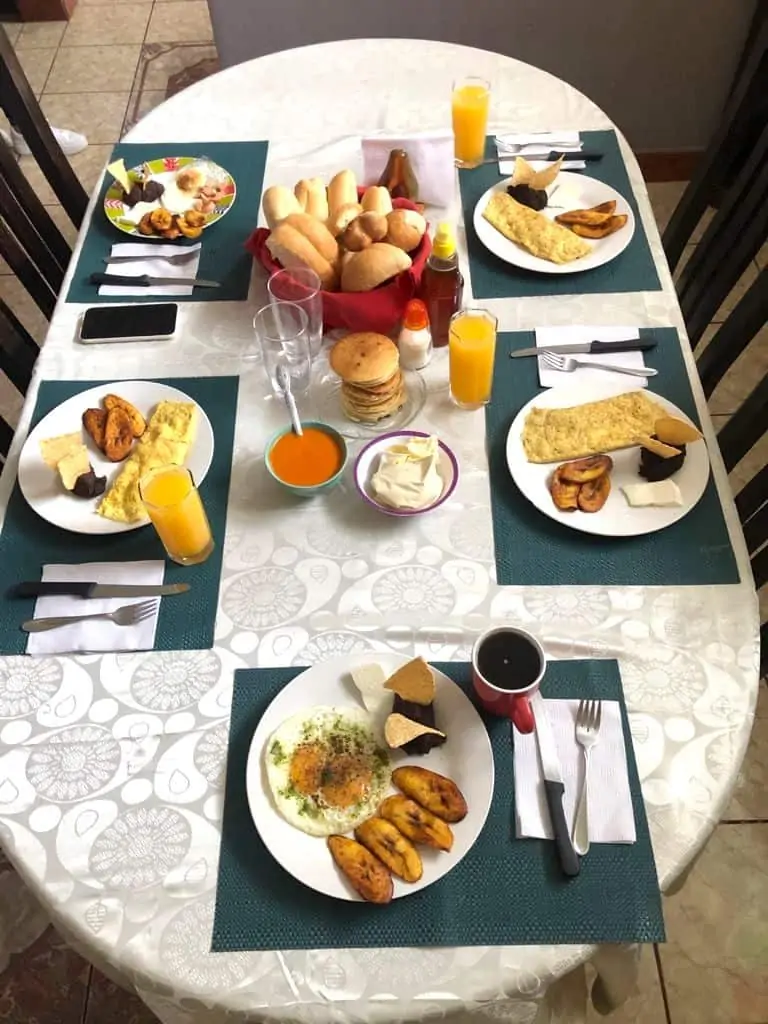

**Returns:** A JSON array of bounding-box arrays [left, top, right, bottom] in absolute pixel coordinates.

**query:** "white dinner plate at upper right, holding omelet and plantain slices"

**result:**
[[474, 171, 635, 273]]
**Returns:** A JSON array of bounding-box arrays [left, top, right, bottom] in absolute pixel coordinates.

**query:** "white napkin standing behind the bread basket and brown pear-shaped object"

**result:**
[[361, 131, 456, 207]]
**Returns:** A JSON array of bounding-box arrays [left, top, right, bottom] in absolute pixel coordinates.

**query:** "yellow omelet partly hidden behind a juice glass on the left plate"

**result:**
[[97, 401, 198, 522]]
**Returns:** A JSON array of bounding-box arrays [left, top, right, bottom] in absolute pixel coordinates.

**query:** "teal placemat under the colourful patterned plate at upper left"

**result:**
[[67, 142, 269, 303]]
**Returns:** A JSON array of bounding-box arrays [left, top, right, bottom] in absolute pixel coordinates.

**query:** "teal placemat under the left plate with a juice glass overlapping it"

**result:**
[[0, 377, 239, 654]]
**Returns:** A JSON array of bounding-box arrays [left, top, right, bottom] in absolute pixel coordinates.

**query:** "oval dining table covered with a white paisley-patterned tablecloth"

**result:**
[[0, 39, 758, 1024]]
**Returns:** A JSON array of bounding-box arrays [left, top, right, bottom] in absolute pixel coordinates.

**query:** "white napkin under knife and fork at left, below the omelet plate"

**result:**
[[27, 558, 165, 654]]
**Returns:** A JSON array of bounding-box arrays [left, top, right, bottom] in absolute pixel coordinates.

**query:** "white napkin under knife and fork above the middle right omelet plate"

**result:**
[[536, 325, 648, 389]]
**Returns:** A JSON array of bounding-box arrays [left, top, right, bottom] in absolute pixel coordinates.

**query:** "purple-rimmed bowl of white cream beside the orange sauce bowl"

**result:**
[[354, 430, 459, 516]]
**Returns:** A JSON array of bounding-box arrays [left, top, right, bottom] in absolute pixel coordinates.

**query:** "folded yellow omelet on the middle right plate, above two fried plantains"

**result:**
[[522, 390, 666, 462]]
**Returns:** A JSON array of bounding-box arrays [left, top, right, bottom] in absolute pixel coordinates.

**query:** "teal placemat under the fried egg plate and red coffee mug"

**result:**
[[212, 660, 664, 952]]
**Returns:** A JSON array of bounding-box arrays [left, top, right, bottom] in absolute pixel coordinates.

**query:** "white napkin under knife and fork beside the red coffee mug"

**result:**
[[514, 700, 636, 843]]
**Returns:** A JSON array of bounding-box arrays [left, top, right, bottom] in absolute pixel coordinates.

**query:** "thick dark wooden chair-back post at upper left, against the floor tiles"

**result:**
[[0, 27, 88, 227]]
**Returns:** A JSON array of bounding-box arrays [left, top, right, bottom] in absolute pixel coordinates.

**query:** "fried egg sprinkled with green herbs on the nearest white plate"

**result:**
[[264, 707, 389, 836]]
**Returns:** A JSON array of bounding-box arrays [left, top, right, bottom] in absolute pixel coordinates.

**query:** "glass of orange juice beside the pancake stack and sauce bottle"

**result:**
[[449, 308, 498, 409]]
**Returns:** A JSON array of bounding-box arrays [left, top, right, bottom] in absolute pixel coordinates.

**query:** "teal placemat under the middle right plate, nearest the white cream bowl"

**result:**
[[485, 328, 738, 587]]
